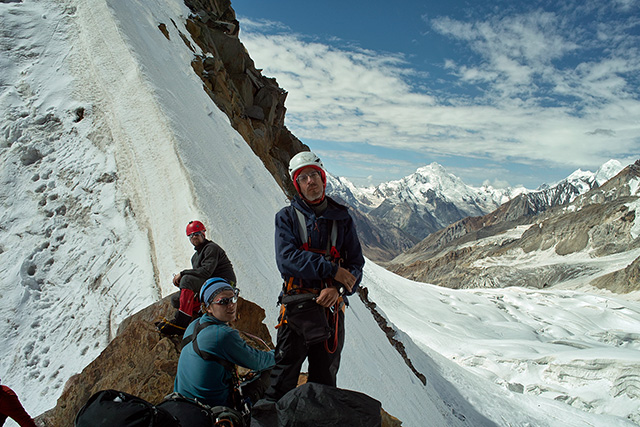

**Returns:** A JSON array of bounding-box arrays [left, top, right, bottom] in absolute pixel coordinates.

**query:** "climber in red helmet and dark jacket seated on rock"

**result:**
[[156, 221, 236, 335]]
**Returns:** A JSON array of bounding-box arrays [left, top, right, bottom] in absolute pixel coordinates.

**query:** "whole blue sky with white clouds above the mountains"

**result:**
[[232, 0, 640, 188]]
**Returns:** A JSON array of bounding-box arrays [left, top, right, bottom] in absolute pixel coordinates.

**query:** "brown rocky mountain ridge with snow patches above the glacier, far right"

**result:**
[[389, 161, 640, 293]]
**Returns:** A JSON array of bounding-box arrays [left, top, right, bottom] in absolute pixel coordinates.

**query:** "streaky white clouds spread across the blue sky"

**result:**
[[241, 4, 640, 177]]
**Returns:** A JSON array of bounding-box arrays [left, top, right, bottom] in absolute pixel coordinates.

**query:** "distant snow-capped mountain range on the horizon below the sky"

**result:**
[[327, 160, 623, 263]]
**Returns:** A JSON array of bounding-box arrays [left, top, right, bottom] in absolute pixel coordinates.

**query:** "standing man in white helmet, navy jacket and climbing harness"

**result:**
[[265, 151, 364, 401]]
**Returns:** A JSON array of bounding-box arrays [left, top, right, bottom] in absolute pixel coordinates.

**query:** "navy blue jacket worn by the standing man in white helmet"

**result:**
[[275, 196, 364, 295]]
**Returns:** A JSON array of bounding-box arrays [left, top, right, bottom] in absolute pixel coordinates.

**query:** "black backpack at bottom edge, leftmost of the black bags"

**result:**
[[74, 390, 180, 427]]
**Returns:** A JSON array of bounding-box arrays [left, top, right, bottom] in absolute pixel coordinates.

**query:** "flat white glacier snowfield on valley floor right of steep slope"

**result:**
[[366, 265, 640, 425]]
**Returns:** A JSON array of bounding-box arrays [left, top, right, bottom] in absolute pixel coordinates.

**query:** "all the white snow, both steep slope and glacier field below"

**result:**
[[0, 0, 640, 426]]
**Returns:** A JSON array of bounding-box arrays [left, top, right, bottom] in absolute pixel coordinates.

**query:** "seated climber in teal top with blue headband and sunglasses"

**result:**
[[174, 277, 275, 409]]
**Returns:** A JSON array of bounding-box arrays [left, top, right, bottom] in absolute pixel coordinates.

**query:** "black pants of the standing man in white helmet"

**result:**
[[265, 310, 344, 400]]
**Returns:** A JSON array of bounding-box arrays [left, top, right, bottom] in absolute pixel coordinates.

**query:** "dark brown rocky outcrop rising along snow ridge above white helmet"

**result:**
[[158, 0, 309, 195]]
